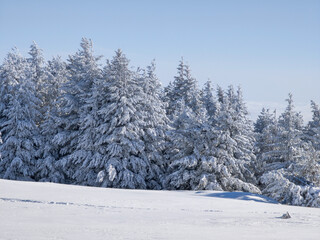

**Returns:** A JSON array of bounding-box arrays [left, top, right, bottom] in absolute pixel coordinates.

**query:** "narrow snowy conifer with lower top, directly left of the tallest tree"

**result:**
[[36, 57, 68, 182]]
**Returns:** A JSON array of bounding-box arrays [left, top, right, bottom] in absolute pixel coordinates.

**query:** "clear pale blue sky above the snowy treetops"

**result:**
[[0, 0, 320, 119]]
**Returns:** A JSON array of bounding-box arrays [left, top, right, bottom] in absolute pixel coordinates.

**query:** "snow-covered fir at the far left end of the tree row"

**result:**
[[0, 49, 41, 180]]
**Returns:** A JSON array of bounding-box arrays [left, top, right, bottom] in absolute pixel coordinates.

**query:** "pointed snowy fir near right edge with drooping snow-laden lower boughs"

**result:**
[[260, 94, 320, 207]]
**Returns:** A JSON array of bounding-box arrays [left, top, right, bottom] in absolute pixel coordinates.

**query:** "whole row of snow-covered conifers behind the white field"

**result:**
[[0, 38, 320, 207]]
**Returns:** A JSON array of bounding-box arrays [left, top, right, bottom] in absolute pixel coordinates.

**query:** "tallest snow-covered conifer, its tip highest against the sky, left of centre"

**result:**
[[53, 38, 100, 182]]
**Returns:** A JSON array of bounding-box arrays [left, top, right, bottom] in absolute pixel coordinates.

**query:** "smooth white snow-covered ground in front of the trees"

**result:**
[[0, 180, 320, 240]]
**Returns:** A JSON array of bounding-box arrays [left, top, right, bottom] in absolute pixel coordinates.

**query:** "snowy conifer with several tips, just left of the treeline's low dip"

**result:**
[[210, 86, 260, 193]]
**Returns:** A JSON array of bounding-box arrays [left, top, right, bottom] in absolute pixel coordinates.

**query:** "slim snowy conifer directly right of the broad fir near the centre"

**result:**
[[140, 61, 169, 189]]
